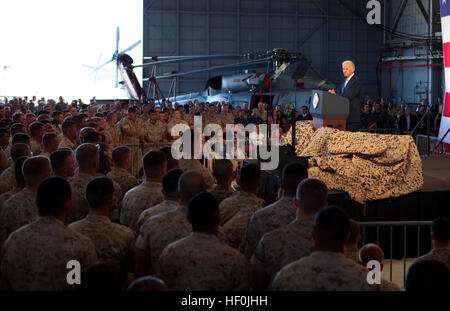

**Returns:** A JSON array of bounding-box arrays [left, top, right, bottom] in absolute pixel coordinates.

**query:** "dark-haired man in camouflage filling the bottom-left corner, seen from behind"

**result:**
[[1, 178, 97, 291]]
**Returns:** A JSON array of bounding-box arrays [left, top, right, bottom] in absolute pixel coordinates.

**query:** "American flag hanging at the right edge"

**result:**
[[439, 0, 450, 152]]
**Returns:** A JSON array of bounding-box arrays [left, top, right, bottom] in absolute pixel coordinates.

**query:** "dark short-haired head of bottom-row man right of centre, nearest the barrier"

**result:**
[[314, 206, 350, 247]]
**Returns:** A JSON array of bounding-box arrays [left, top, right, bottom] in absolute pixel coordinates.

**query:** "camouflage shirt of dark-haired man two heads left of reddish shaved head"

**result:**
[[120, 181, 164, 232]]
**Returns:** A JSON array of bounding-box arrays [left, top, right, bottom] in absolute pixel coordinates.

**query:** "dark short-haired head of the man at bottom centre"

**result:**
[[188, 192, 219, 230]]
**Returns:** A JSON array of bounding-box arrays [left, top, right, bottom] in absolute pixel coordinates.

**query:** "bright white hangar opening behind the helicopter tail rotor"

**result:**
[[0, 0, 143, 102]]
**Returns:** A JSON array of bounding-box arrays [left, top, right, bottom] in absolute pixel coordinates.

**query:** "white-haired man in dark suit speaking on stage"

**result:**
[[330, 60, 361, 132]]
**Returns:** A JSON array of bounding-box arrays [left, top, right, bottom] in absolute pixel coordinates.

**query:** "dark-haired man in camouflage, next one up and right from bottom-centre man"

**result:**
[[219, 164, 264, 225]]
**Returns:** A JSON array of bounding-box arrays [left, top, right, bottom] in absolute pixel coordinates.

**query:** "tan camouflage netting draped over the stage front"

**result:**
[[284, 121, 423, 204]]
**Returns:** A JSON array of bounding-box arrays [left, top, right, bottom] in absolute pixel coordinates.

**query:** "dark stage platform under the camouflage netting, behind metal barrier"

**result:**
[[328, 156, 450, 258]]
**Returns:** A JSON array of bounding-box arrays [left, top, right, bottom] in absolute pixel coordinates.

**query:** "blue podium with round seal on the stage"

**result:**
[[309, 90, 350, 131]]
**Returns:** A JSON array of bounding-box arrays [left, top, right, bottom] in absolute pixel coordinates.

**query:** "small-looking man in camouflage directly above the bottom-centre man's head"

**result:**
[[211, 159, 235, 204]]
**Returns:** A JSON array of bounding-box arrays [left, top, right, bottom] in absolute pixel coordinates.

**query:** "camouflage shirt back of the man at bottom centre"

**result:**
[[159, 232, 251, 291]]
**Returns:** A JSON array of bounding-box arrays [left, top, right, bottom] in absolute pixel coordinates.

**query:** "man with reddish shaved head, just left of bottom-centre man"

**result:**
[[135, 170, 206, 277]]
